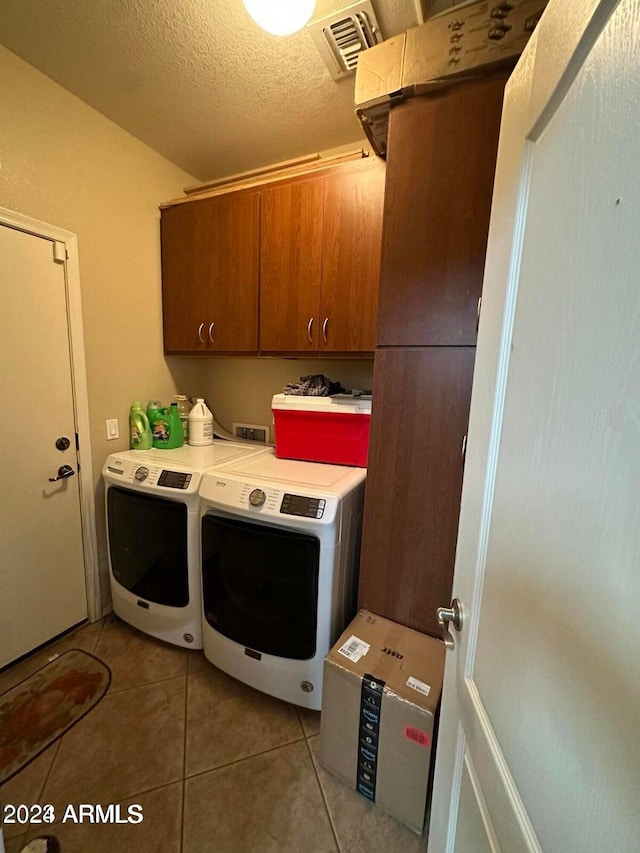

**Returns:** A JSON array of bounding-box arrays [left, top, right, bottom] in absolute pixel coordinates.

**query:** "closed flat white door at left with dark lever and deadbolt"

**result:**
[[0, 220, 87, 666]]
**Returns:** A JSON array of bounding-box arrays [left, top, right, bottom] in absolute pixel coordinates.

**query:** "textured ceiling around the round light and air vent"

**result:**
[[0, 0, 460, 180]]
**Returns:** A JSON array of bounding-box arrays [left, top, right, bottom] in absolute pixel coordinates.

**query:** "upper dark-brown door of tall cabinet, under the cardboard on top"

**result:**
[[378, 73, 507, 346]]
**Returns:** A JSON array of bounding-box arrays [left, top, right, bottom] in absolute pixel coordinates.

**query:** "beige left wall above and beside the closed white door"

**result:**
[[0, 47, 202, 604]]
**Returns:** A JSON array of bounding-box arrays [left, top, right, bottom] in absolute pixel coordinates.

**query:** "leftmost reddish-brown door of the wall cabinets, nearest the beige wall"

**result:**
[[160, 204, 211, 353]]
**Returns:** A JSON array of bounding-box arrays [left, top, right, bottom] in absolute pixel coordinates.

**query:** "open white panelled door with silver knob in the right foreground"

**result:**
[[429, 0, 640, 853]]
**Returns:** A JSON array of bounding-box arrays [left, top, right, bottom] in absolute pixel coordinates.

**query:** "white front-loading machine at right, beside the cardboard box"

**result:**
[[200, 451, 366, 710]]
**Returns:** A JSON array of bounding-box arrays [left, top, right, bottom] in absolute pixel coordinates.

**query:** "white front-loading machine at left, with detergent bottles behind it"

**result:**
[[102, 440, 267, 649]]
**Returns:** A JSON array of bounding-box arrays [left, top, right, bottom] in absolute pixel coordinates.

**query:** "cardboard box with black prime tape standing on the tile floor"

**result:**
[[320, 610, 445, 833]]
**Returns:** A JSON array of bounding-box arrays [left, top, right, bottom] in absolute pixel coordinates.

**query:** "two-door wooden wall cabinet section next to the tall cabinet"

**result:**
[[260, 158, 385, 354]]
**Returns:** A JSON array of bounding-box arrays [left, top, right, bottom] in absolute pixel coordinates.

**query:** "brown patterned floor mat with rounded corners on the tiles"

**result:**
[[0, 649, 111, 785]]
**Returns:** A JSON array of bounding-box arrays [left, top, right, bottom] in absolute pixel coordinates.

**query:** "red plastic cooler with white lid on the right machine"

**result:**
[[271, 394, 371, 468]]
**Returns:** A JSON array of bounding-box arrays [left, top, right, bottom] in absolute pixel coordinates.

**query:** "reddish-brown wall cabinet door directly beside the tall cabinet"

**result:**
[[319, 160, 385, 352]]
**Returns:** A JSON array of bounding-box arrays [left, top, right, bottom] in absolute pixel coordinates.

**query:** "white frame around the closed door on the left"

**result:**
[[0, 207, 102, 622]]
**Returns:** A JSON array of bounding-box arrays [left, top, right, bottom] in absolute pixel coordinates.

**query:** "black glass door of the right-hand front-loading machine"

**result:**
[[202, 514, 320, 660]]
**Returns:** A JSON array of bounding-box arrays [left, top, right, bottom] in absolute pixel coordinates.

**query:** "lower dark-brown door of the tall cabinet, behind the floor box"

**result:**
[[358, 347, 475, 636]]
